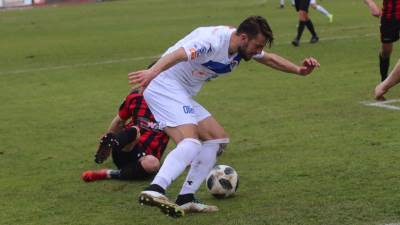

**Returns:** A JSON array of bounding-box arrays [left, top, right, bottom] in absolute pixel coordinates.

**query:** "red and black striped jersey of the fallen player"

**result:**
[[118, 91, 169, 159]]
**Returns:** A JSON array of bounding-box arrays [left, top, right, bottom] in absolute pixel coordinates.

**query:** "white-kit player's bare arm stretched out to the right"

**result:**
[[255, 53, 320, 76]]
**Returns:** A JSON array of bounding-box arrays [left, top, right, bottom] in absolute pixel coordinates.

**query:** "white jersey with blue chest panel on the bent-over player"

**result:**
[[155, 26, 264, 96]]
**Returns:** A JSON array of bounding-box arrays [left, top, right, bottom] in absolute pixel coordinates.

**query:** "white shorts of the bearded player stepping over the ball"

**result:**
[[143, 79, 211, 129]]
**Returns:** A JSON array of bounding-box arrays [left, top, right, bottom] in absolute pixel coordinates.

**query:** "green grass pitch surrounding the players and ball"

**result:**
[[0, 0, 400, 225]]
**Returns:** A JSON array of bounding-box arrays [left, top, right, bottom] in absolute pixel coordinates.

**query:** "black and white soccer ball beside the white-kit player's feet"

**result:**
[[206, 165, 239, 198]]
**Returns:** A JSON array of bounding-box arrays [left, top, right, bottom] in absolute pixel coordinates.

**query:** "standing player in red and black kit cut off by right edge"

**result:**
[[364, 0, 400, 81]]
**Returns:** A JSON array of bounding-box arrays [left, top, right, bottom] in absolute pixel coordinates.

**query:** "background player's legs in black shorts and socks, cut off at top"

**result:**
[[292, 0, 319, 47]]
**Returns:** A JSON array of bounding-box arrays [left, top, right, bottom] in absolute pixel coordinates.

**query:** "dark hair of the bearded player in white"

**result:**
[[237, 16, 274, 47]]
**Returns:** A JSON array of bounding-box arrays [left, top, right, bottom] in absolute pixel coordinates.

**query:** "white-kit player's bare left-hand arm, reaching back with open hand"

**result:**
[[128, 48, 188, 87]]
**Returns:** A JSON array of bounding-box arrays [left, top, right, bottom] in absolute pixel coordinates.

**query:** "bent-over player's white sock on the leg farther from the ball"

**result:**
[[151, 138, 201, 190]]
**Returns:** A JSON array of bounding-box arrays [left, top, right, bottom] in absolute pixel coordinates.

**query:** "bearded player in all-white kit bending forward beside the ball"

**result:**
[[128, 16, 319, 217]]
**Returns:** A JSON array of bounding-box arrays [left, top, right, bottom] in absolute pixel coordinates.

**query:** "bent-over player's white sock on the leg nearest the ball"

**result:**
[[179, 139, 225, 195]]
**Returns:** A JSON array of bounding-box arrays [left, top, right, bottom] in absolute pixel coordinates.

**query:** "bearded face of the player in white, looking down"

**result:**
[[238, 34, 267, 61]]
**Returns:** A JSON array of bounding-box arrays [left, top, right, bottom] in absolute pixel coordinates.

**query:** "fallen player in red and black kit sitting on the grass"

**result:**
[[82, 90, 169, 182]]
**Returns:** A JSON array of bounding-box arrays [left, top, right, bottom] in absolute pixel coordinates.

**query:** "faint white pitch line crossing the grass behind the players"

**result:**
[[0, 33, 377, 76]]
